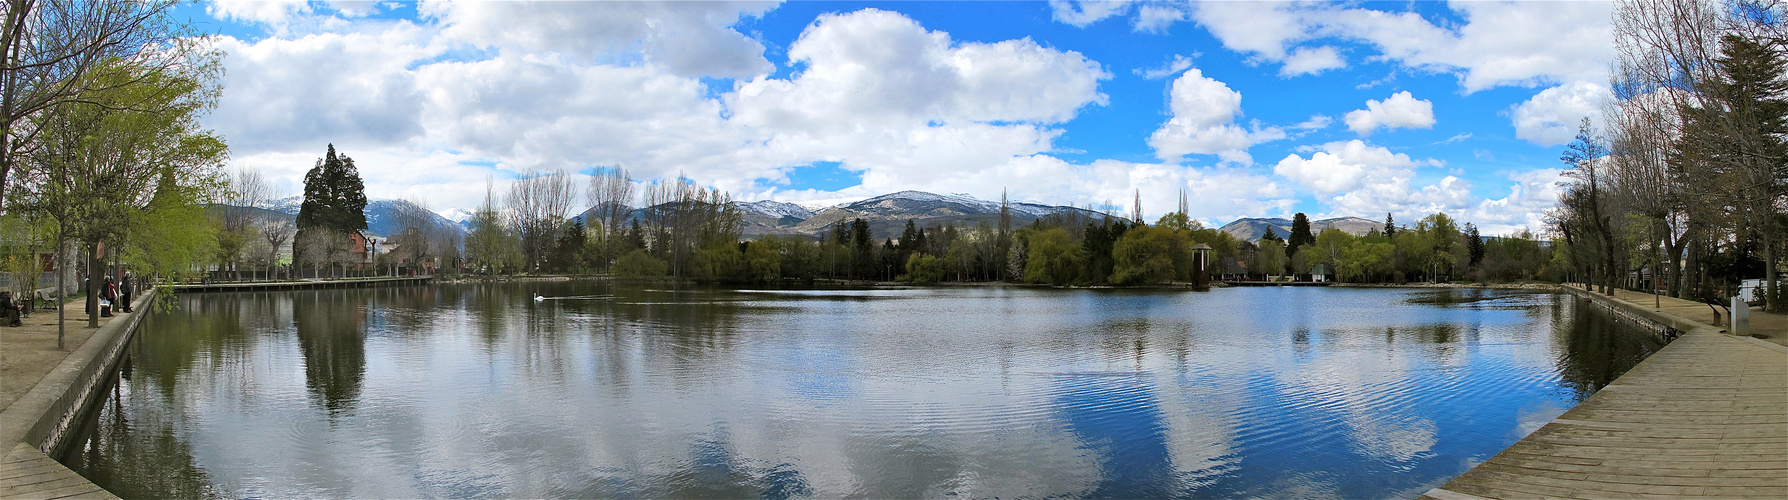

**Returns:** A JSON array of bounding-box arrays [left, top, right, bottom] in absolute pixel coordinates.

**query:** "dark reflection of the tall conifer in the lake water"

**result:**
[[291, 291, 367, 414]]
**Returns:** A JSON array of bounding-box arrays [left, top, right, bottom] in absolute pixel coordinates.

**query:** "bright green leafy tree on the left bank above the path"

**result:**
[[11, 60, 229, 337]]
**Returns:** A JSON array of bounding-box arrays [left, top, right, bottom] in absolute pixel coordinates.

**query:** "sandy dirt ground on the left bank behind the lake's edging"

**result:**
[[0, 298, 116, 411]]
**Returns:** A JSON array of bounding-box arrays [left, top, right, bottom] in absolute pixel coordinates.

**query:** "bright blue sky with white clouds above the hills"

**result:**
[[182, 0, 1613, 232]]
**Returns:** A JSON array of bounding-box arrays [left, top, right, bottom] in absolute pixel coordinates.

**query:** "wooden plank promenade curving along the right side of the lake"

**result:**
[[1421, 289, 1788, 500]]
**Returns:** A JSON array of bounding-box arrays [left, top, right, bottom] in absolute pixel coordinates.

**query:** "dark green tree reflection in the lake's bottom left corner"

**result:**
[[57, 361, 218, 498]]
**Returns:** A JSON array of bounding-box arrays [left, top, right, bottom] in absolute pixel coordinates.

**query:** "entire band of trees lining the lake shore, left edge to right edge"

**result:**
[[0, 0, 1788, 311]]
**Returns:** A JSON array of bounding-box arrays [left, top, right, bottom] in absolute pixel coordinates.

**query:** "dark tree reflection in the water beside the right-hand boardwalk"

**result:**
[[1552, 300, 1663, 402]]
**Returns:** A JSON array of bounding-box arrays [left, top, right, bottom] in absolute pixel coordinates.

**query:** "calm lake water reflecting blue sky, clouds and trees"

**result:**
[[61, 280, 1661, 498]]
